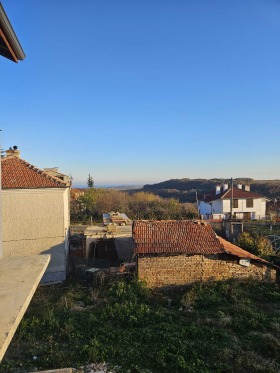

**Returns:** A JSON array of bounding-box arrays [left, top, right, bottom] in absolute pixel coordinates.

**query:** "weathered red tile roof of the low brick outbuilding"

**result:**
[[132, 220, 225, 254]]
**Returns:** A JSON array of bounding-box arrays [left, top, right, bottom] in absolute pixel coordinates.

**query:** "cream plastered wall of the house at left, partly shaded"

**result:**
[[2, 188, 70, 282]]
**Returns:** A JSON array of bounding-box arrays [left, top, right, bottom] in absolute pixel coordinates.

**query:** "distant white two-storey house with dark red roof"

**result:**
[[198, 183, 267, 220]]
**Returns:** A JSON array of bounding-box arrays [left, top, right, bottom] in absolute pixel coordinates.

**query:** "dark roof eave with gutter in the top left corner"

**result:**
[[0, 3, 25, 62]]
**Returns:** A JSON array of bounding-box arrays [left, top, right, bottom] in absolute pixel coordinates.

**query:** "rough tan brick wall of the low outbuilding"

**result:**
[[137, 255, 276, 287]]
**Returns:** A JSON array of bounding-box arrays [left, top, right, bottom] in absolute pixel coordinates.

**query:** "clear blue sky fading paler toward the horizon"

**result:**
[[0, 0, 280, 186]]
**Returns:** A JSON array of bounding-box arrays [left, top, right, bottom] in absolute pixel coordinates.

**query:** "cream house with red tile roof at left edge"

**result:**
[[1, 148, 70, 282]]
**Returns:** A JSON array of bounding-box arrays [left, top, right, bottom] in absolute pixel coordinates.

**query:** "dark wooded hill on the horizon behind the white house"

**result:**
[[137, 177, 280, 202]]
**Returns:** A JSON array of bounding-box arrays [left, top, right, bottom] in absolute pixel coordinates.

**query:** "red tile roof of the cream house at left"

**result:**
[[1, 157, 67, 189]]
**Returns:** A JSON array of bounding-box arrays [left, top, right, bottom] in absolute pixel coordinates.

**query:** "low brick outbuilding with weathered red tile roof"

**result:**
[[132, 220, 277, 287]]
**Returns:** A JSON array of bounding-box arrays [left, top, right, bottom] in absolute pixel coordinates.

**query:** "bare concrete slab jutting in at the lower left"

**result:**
[[0, 255, 50, 361]]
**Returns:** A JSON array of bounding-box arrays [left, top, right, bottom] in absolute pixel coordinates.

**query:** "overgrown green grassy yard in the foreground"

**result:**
[[0, 278, 280, 373]]
